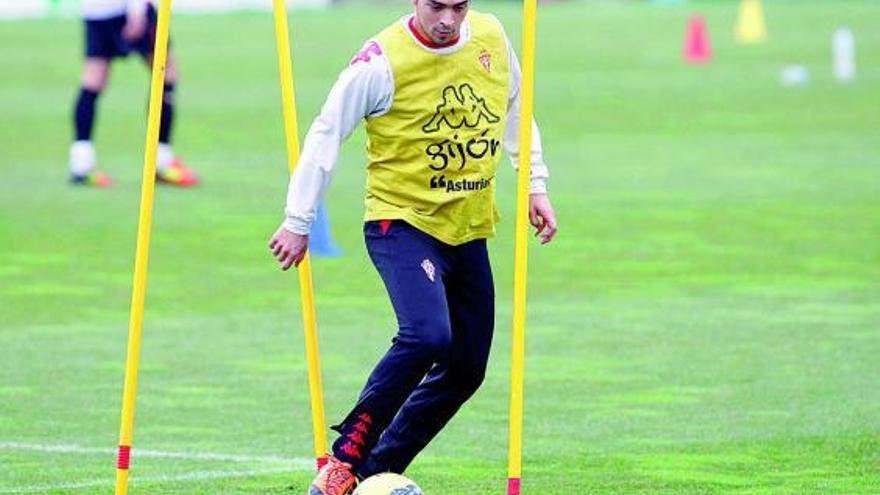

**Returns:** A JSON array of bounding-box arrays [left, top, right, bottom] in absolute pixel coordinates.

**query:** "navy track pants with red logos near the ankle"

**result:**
[[333, 220, 495, 478]]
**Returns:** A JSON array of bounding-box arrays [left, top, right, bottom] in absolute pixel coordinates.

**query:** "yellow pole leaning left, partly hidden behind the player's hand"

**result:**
[[274, 0, 327, 469]]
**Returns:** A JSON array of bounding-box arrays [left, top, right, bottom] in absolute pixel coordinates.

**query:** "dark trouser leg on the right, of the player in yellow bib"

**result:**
[[357, 240, 495, 477]]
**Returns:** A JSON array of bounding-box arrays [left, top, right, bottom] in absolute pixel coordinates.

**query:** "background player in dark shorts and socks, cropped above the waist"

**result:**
[[70, 0, 199, 187]]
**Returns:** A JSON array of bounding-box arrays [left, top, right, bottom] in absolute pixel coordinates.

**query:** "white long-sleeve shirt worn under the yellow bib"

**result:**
[[284, 15, 549, 235]]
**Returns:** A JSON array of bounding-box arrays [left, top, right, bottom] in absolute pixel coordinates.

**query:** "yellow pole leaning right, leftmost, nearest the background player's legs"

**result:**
[[116, 0, 171, 495]]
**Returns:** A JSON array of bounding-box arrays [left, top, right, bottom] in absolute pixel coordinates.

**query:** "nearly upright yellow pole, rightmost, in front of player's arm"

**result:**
[[507, 0, 537, 495]]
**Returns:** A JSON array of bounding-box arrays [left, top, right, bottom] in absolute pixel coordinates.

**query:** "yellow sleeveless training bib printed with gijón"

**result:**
[[365, 11, 510, 245]]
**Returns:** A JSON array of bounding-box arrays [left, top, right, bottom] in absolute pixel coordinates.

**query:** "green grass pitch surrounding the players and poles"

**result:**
[[0, 0, 880, 495]]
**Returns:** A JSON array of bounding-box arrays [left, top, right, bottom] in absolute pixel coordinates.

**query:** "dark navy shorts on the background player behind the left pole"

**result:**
[[85, 4, 156, 58]]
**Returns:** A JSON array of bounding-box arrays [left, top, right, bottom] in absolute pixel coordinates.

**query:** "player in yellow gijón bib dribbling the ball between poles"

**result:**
[[269, 0, 557, 495]]
